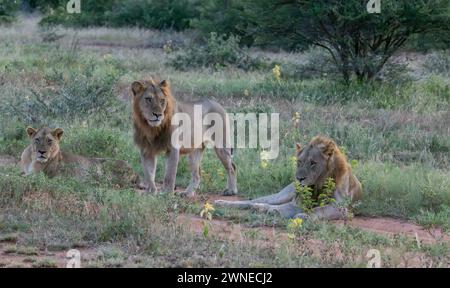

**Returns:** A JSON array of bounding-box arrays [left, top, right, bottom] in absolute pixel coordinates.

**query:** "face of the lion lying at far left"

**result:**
[[27, 127, 63, 163]]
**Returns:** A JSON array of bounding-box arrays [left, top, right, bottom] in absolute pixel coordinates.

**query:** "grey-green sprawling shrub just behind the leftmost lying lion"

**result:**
[[0, 53, 121, 125]]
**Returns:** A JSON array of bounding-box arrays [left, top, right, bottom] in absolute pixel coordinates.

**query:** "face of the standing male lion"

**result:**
[[131, 81, 168, 127]]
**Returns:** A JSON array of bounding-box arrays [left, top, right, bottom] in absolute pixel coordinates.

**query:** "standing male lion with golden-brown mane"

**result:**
[[131, 78, 237, 197]]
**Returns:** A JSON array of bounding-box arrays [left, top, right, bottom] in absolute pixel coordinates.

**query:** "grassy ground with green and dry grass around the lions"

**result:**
[[0, 18, 450, 267]]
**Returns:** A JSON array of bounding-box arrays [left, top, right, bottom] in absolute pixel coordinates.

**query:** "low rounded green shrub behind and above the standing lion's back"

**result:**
[[170, 32, 263, 70]]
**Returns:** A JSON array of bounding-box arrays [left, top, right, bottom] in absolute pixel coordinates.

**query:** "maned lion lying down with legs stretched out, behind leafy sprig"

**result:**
[[215, 136, 362, 220]]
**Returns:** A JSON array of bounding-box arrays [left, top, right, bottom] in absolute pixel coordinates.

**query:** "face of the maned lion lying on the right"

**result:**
[[295, 140, 334, 186]]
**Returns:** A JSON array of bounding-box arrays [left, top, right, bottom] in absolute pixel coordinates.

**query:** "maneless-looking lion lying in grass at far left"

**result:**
[[20, 127, 138, 185]]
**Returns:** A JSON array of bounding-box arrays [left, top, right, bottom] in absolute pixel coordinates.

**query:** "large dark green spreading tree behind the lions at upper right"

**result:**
[[245, 0, 450, 82]]
